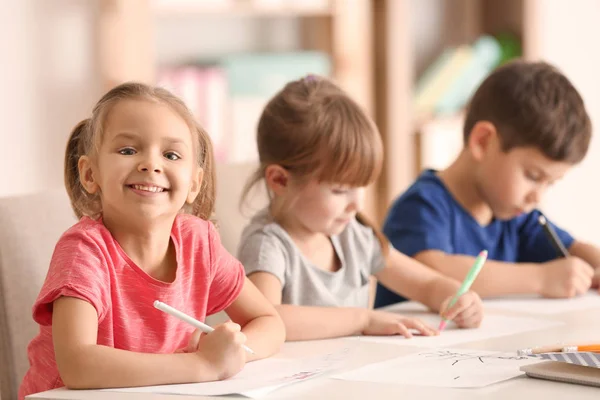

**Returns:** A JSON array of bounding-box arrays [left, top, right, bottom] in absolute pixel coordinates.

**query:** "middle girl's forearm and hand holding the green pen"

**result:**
[[376, 249, 486, 327]]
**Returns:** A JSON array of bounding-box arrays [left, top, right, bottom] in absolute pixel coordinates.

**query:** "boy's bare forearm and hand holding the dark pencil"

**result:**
[[415, 250, 593, 297]]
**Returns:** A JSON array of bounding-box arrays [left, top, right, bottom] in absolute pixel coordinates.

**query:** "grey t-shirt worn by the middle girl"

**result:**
[[238, 209, 385, 307]]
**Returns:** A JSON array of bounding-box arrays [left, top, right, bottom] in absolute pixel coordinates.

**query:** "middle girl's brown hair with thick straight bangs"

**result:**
[[242, 75, 383, 202]]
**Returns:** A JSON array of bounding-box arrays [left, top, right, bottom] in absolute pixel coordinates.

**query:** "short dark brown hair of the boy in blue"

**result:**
[[463, 60, 592, 164]]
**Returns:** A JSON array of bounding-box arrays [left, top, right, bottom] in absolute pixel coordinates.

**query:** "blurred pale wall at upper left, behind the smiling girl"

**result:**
[[0, 0, 99, 196]]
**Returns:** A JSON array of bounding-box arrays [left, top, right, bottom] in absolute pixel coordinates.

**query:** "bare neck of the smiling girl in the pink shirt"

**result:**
[[102, 214, 177, 282]]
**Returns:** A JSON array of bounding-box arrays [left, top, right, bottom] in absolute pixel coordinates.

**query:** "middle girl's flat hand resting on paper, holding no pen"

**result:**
[[362, 310, 439, 338]]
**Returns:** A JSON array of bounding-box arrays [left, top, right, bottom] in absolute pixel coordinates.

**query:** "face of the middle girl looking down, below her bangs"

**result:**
[[287, 179, 364, 236]]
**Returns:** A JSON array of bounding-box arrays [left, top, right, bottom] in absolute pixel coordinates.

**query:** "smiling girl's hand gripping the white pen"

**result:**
[[195, 321, 246, 380]]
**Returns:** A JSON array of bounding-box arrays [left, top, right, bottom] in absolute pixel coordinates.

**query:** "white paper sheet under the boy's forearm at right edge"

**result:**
[[483, 290, 600, 315]]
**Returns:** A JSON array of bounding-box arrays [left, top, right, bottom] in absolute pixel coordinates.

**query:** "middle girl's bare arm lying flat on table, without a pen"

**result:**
[[249, 272, 435, 341]]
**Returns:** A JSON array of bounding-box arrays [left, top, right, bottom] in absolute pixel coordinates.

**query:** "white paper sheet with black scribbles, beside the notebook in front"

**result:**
[[332, 349, 539, 388]]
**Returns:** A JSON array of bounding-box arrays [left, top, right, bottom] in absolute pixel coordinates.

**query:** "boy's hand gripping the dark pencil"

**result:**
[[540, 256, 594, 298]]
